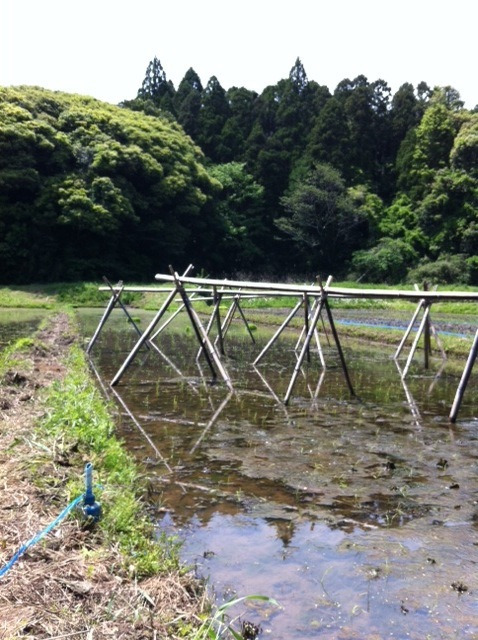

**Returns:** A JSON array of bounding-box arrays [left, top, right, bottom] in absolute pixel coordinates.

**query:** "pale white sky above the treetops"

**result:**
[[0, 0, 478, 108]]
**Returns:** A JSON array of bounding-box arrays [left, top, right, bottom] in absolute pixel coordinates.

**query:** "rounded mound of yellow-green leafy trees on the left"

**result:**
[[0, 88, 219, 282]]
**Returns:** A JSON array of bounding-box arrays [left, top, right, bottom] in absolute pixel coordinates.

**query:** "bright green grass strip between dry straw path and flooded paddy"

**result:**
[[39, 346, 179, 577]]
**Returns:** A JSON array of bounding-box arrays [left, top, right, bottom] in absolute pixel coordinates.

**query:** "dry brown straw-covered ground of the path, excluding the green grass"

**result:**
[[0, 314, 204, 640]]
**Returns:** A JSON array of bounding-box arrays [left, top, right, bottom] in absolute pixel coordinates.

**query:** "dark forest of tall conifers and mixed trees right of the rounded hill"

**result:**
[[127, 59, 478, 283]]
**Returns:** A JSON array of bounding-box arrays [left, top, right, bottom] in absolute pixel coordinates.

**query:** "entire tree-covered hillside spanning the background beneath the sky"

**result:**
[[0, 58, 478, 284]]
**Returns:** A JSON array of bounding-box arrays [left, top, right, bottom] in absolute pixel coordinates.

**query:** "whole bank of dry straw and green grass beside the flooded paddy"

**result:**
[[0, 313, 211, 639]]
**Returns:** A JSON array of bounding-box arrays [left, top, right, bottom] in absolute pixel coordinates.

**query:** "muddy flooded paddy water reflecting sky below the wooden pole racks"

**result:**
[[79, 312, 478, 640]]
